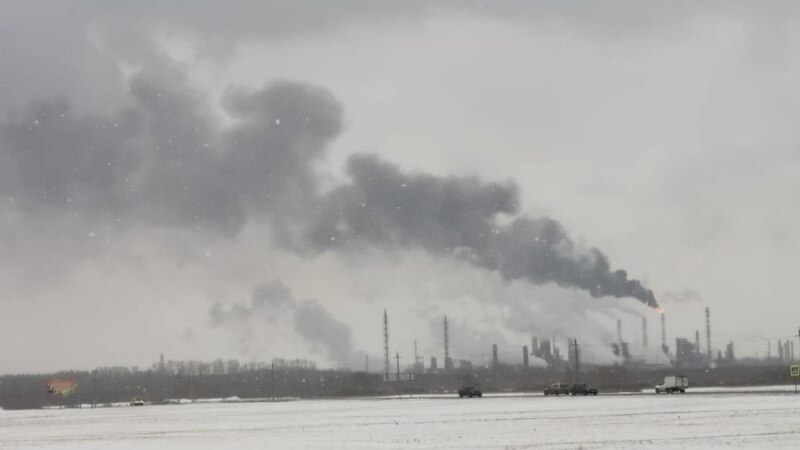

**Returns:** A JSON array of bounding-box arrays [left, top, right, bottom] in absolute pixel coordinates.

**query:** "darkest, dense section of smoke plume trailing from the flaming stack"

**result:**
[[307, 155, 658, 307]]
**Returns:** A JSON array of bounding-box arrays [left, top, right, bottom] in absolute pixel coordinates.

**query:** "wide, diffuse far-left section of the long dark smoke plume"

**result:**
[[0, 68, 342, 235]]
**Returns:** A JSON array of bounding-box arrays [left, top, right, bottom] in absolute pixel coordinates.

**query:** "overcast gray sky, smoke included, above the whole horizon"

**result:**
[[0, 0, 800, 373]]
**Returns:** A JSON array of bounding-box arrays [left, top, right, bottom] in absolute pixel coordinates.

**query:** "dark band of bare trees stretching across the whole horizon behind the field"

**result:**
[[0, 360, 792, 409]]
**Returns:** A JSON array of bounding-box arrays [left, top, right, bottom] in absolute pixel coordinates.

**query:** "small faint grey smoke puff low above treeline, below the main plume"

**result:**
[[209, 282, 362, 367]]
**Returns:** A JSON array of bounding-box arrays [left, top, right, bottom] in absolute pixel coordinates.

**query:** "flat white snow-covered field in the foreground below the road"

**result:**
[[0, 393, 800, 449]]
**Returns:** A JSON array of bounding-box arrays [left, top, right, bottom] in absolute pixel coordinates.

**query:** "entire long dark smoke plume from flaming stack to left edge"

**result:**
[[0, 65, 657, 307]]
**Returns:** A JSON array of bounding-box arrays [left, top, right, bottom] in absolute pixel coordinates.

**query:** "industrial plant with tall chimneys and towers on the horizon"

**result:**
[[364, 308, 797, 400]]
